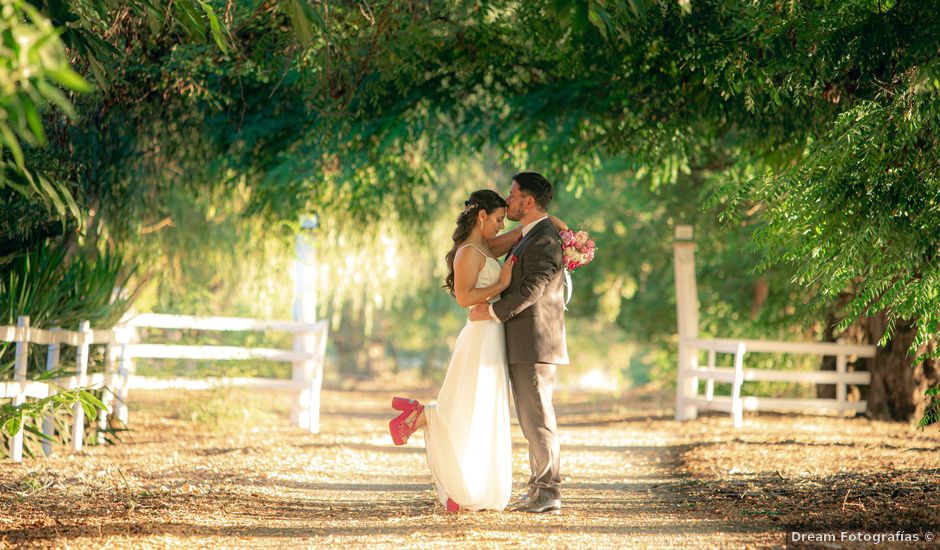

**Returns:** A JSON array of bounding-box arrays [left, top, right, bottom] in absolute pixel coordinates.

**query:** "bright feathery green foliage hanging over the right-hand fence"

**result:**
[[720, 52, 940, 362]]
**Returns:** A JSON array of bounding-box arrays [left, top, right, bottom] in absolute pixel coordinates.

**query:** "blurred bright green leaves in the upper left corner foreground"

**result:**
[[0, 0, 235, 242]]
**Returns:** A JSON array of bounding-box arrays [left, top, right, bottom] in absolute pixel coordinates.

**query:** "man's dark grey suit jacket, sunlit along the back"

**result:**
[[493, 219, 568, 365]]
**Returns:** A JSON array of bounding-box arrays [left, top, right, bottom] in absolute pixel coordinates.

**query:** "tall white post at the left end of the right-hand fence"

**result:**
[[672, 225, 698, 420]]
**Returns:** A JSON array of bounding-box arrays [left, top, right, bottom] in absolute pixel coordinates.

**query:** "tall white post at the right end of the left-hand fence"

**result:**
[[291, 215, 320, 433]]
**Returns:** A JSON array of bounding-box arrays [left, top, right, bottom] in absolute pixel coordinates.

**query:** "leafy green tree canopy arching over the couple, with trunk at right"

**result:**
[[3, 0, 940, 424]]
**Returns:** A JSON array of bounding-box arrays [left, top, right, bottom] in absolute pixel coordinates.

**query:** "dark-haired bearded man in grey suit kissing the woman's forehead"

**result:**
[[470, 172, 568, 513]]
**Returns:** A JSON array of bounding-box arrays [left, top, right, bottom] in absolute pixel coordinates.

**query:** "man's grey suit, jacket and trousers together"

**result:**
[[493, 219, 568, 498]]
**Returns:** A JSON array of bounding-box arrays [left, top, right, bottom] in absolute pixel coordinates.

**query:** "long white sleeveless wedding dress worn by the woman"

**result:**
[[424, 245, 512, 510]]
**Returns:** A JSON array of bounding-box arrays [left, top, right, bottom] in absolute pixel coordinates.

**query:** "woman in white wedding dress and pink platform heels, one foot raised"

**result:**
[[389, 189, 564, 512]]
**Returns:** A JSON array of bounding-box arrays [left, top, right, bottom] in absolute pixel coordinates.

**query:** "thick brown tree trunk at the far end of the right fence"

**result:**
[[864, 315, 940, 420]]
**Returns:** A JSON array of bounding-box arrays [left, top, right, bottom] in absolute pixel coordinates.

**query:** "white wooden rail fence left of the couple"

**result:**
[[0, 314, 328, 462]]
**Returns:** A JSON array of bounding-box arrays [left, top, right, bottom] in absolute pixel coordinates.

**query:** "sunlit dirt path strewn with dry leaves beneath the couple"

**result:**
[[0, 390, 940, 548]]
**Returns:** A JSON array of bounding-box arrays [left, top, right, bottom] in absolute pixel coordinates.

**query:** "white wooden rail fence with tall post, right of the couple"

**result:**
[[673, 226, 876, 428]]
